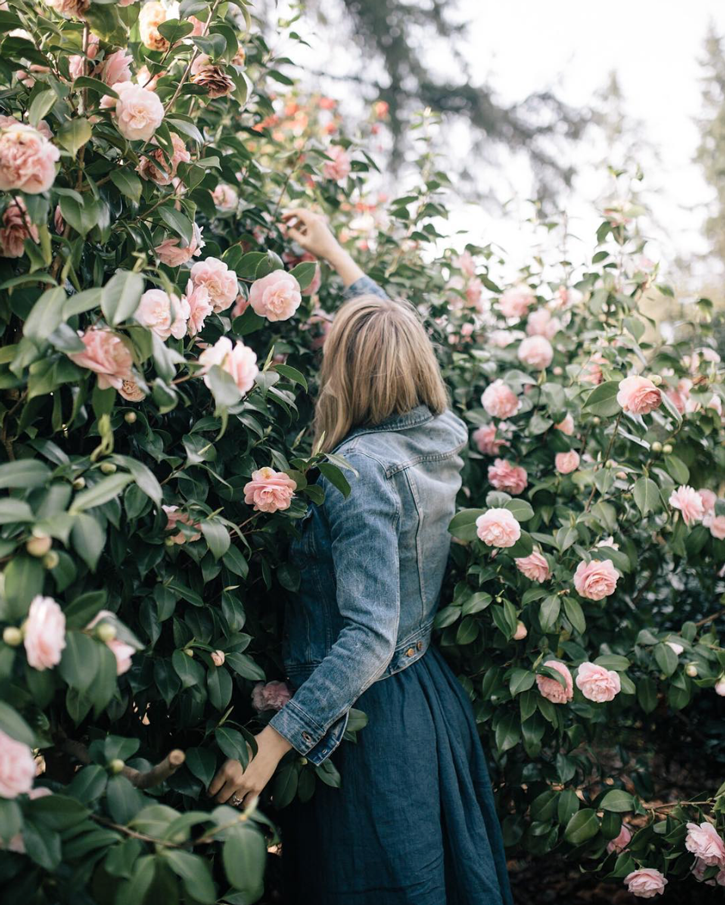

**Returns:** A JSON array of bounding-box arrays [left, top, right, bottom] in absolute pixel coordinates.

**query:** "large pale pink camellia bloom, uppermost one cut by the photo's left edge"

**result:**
[[0, 122, 60, 195]]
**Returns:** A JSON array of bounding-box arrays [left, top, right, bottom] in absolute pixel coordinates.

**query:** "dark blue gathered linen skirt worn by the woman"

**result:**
[[275, 644, 512, 905]]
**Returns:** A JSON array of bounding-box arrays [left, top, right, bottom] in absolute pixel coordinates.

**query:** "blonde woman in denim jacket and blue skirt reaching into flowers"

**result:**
[[210, 210, 511, 905]]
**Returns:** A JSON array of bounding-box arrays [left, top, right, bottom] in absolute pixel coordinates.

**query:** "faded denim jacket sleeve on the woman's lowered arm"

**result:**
[[270, 452, 400, 754]]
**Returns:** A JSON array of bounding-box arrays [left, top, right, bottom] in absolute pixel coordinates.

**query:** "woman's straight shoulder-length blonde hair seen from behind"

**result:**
[[315, 295, 448, 452]]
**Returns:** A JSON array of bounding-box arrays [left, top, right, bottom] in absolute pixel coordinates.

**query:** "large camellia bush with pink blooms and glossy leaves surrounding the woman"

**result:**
[[0, 0, 725, 905]]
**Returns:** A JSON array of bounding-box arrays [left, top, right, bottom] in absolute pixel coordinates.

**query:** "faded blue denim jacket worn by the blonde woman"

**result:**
[[270, 277, 468, 764]]
